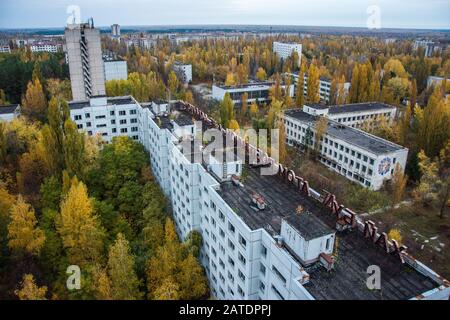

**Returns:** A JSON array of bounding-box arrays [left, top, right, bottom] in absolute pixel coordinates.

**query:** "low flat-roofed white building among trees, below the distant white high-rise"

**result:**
[[212, 81, 294, 105]]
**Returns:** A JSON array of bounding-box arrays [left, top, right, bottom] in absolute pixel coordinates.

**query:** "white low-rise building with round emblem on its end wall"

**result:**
[[284, 105, 408, 190]]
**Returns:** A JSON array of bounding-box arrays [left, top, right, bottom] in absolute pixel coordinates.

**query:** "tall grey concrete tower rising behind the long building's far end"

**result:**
[[65, 18, 105, 101]]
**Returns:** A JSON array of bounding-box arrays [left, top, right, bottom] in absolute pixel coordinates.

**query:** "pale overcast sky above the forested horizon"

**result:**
[[0, 0, 450, 29]]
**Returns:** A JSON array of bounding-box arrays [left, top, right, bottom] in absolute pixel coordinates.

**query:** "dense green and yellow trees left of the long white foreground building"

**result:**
[[0, 63, 208, 300]]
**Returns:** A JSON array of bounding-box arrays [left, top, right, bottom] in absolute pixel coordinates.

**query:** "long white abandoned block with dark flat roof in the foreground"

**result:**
[[1, 97, 450, 300]]
